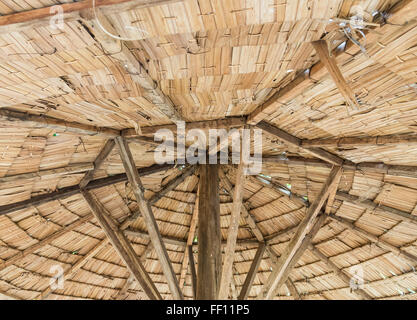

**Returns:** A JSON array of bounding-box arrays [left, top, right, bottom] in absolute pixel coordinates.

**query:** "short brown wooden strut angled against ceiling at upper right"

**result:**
[[311, 40, 359, 109]]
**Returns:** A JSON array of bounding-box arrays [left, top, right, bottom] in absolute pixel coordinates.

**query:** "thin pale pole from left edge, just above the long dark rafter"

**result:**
[[0, 162, 94, 183]]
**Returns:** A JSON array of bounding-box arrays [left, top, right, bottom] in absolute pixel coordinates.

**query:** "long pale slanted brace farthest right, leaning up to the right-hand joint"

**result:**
[[260, 167, 342, 299]]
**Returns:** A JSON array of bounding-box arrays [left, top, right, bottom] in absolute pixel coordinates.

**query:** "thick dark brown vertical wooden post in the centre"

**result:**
[[196, 164, 222, 300]]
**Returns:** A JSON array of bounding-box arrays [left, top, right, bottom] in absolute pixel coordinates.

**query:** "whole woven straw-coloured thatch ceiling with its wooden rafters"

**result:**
[[0, 0, 417, 300]]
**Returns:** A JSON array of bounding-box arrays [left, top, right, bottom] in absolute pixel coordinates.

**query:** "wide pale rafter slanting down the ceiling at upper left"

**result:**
[[82, 9, 182, 122]]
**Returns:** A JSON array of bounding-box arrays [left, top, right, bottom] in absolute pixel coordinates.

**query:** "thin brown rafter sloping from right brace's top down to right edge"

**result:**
[[336, 191, 417, 224]]
